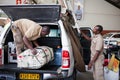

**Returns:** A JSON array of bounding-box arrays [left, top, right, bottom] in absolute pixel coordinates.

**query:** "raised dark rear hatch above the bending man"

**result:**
[[0, 5, 61, 23]]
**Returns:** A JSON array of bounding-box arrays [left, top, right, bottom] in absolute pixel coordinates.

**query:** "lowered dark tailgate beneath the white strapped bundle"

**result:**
[[0, 64, 60, 74]]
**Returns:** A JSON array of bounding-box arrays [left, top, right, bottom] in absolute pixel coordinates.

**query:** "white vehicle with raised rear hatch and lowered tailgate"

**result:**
[[0, 5, 86, 80]]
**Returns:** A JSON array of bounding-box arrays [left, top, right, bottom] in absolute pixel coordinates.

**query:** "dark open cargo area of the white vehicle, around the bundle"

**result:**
[[0, 25, 62, 73]]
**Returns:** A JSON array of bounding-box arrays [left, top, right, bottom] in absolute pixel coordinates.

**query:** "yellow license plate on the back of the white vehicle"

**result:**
[[19, 73, 41, 80]]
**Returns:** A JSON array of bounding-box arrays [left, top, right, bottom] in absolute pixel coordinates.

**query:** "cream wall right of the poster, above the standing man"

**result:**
[[79, 0, 120, 30]]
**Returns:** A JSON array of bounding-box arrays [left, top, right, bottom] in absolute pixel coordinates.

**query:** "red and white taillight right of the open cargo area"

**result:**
[[62, 50, 70, 68]]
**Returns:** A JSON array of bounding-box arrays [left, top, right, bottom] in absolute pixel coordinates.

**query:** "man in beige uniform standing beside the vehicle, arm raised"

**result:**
[[81, 25, 104, 80]]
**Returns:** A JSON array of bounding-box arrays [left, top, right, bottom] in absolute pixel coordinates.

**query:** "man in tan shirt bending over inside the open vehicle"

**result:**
[[11, 19, 50, 55]]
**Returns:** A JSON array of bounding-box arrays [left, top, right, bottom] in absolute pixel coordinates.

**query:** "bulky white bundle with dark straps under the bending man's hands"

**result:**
[[17, 46, 54, 69]]
